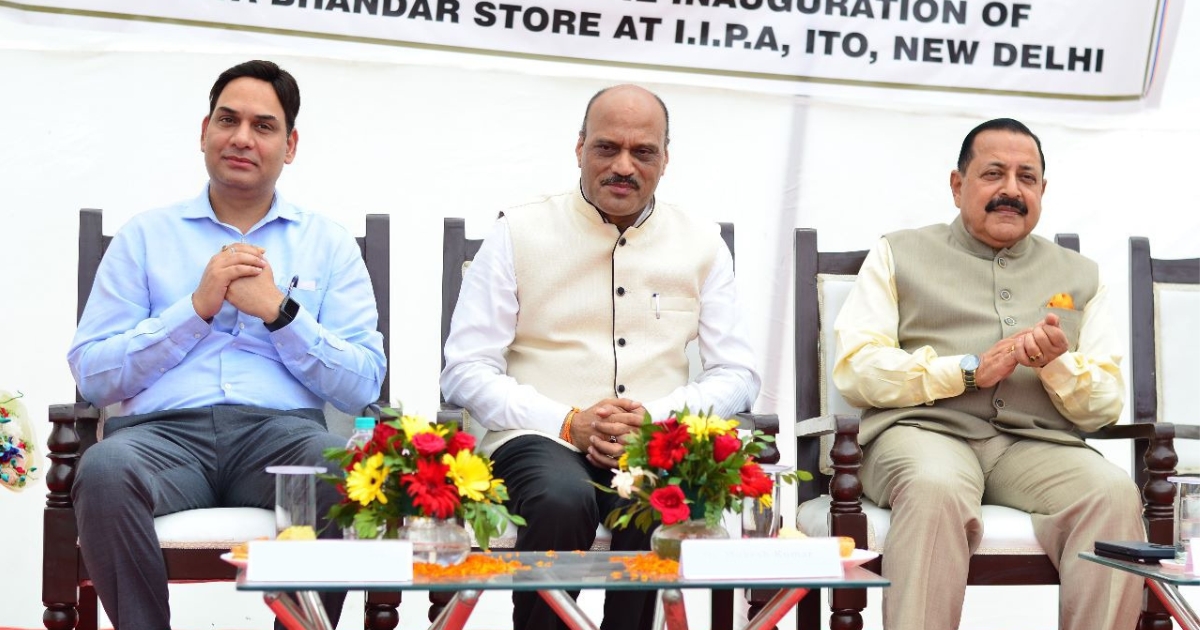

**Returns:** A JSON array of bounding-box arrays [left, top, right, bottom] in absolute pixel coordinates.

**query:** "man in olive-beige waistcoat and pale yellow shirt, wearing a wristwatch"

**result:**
[[834, 119, 1146, 630]]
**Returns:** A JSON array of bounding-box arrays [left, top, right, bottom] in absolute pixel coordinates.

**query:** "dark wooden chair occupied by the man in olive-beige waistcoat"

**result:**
[[794, 229, 1176, 629]]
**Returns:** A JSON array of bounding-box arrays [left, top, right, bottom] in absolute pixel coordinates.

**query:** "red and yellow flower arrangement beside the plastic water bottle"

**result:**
[[323, 408, 524, 550]]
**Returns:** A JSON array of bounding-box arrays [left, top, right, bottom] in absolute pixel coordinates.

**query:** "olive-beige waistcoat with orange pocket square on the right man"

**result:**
[[863, 218, 1099, 444]]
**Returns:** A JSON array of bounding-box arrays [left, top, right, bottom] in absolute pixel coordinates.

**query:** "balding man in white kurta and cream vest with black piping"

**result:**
[[442, 85, 760, 630]]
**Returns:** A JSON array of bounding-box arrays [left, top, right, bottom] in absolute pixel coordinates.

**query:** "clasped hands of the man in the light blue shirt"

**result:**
[[192, 242, 283, 322]]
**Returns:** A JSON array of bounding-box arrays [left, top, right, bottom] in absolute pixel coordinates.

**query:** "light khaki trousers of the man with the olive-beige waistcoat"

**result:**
[[862, 426, 1146, 630]]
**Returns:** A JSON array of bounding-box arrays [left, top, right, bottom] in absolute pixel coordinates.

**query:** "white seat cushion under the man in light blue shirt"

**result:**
[[154, 508, 275, 548]]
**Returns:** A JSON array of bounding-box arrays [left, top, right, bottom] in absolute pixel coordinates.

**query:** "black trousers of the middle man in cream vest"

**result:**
[[492, 436, 658, 630]]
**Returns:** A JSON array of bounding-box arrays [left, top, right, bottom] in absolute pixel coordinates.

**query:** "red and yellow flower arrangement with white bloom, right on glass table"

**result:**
[[604, 409, 812, 532]]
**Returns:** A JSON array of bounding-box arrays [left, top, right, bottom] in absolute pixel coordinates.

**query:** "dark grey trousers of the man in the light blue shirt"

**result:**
[[71, 406, 346, 630]]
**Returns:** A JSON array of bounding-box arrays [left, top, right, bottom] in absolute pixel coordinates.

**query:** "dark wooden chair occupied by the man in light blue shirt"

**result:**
[[42, 209, 400, 630]]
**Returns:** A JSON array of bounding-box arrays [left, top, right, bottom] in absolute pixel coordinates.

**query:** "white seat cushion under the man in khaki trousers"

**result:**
[[796, 494, 1045, 556]]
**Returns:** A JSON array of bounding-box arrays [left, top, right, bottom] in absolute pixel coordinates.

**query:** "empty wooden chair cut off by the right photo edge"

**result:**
[[1129, 236, 1200, 484]]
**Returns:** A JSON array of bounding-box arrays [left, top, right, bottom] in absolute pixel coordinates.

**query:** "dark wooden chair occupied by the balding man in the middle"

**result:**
[[430, 218, 779, 630]]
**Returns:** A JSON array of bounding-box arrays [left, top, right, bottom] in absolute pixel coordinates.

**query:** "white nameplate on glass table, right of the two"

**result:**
[[679, 538, 845, 580]]
